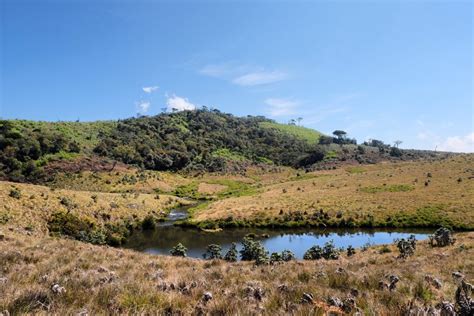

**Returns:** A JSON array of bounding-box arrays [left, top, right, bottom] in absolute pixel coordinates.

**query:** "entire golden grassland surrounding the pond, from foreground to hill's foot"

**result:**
[[0, 155, 474, 315]]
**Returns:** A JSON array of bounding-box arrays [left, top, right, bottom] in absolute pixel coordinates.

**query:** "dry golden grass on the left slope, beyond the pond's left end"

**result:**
[[0, 181, 189, 235]]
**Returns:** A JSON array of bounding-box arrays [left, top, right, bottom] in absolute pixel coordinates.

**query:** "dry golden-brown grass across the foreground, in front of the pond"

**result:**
[[0, 231, 474, 315]]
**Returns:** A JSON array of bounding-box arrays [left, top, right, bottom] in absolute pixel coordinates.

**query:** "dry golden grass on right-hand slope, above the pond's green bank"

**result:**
[[193, 154, 474, 228]]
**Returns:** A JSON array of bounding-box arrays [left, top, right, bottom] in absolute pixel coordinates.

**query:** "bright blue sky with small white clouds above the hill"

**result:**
[[0, 0, 474, 152]]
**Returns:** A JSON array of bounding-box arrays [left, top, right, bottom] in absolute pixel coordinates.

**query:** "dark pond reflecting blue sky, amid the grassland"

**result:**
[[124, 204, 433, 259]]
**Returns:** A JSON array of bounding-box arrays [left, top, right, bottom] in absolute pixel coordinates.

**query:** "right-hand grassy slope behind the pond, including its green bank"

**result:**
[[191, 155, 474, 229]]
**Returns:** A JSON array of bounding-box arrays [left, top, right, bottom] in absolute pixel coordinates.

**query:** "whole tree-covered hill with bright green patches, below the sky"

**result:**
[[0, 109, 448, 182]]
